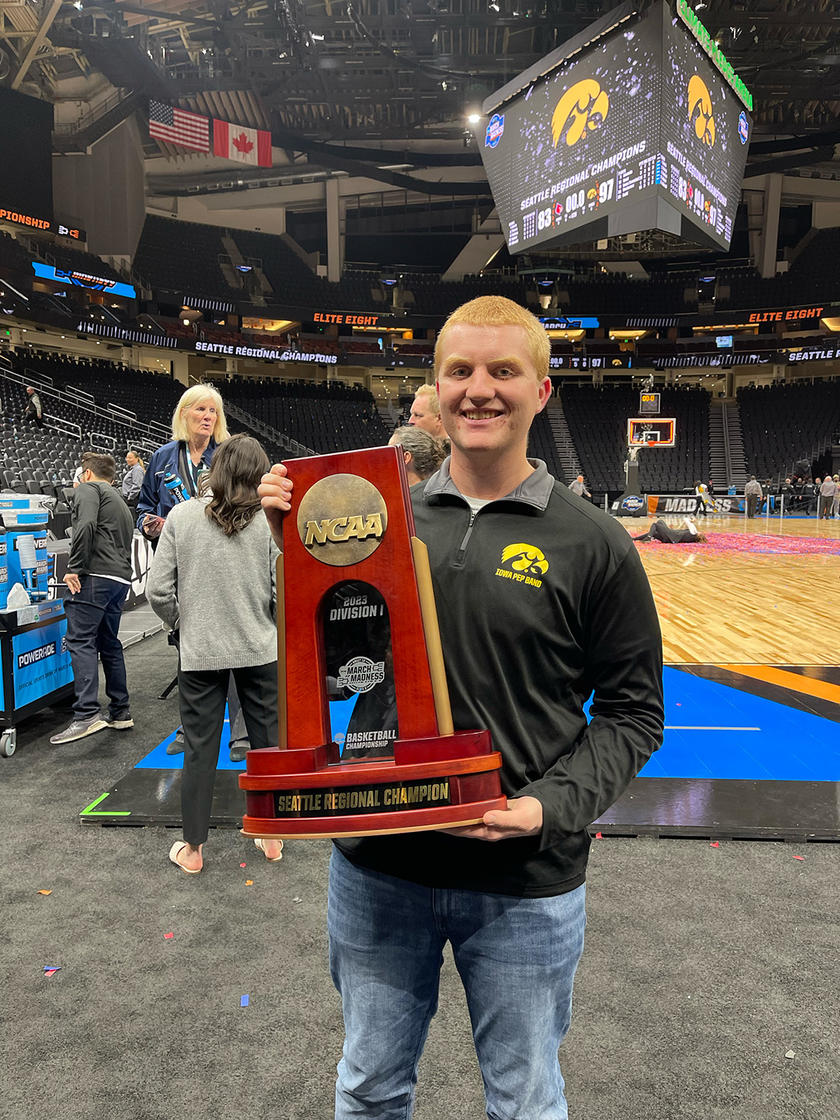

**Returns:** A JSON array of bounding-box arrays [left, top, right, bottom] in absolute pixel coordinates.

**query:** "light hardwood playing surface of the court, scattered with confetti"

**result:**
[[623, 515, 840, 665]]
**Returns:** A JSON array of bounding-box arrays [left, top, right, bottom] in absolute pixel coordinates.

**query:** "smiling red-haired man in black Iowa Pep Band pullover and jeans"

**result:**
[[260, 297, 663, 1120]]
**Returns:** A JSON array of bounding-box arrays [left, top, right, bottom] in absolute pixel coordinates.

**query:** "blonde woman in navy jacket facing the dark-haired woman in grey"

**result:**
[[137, 385, 228, 540]]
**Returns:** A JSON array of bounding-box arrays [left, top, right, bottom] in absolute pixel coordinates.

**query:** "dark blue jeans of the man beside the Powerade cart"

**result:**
[[64, 576, 129, 720]]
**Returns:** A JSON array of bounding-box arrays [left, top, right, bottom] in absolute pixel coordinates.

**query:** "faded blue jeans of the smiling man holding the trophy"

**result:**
[[328, 848, 586, 1120]]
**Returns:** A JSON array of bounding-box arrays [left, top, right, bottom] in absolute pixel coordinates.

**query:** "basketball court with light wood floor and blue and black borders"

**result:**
[[80, 481, 840, 841]]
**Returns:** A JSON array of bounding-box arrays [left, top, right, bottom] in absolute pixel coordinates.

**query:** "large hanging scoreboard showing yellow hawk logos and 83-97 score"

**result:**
[[478, 0, 753, 253]]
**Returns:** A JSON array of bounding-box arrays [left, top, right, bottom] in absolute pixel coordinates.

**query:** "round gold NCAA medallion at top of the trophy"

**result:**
[[298, 475, 388, 568]]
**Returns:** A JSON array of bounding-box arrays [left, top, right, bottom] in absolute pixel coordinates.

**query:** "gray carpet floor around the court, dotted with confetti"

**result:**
[[0, 636, 840, 1120]]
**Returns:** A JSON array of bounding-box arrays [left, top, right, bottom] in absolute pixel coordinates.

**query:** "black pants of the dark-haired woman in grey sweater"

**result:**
[[178, 661, 278, 848]]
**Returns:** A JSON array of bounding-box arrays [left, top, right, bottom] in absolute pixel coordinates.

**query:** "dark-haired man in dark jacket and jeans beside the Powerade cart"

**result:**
[[49, 452, 134, 744]]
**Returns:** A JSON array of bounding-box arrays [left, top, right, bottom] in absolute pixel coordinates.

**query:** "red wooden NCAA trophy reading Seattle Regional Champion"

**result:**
[[240, 447, 506, 839]]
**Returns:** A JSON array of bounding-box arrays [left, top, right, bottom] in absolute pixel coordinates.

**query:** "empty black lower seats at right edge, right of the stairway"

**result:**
[[738, 380, 840, 480]]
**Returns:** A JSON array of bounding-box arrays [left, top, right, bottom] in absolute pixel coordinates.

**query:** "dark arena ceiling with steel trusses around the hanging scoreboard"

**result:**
[[0, 0, 840, 201]]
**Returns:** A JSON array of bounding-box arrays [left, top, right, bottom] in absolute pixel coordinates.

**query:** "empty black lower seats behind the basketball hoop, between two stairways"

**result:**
[[560, 385, 710, 494]]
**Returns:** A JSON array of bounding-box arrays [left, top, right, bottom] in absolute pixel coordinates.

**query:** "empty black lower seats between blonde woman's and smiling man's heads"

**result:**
[[220, 377, 391, 455]]
